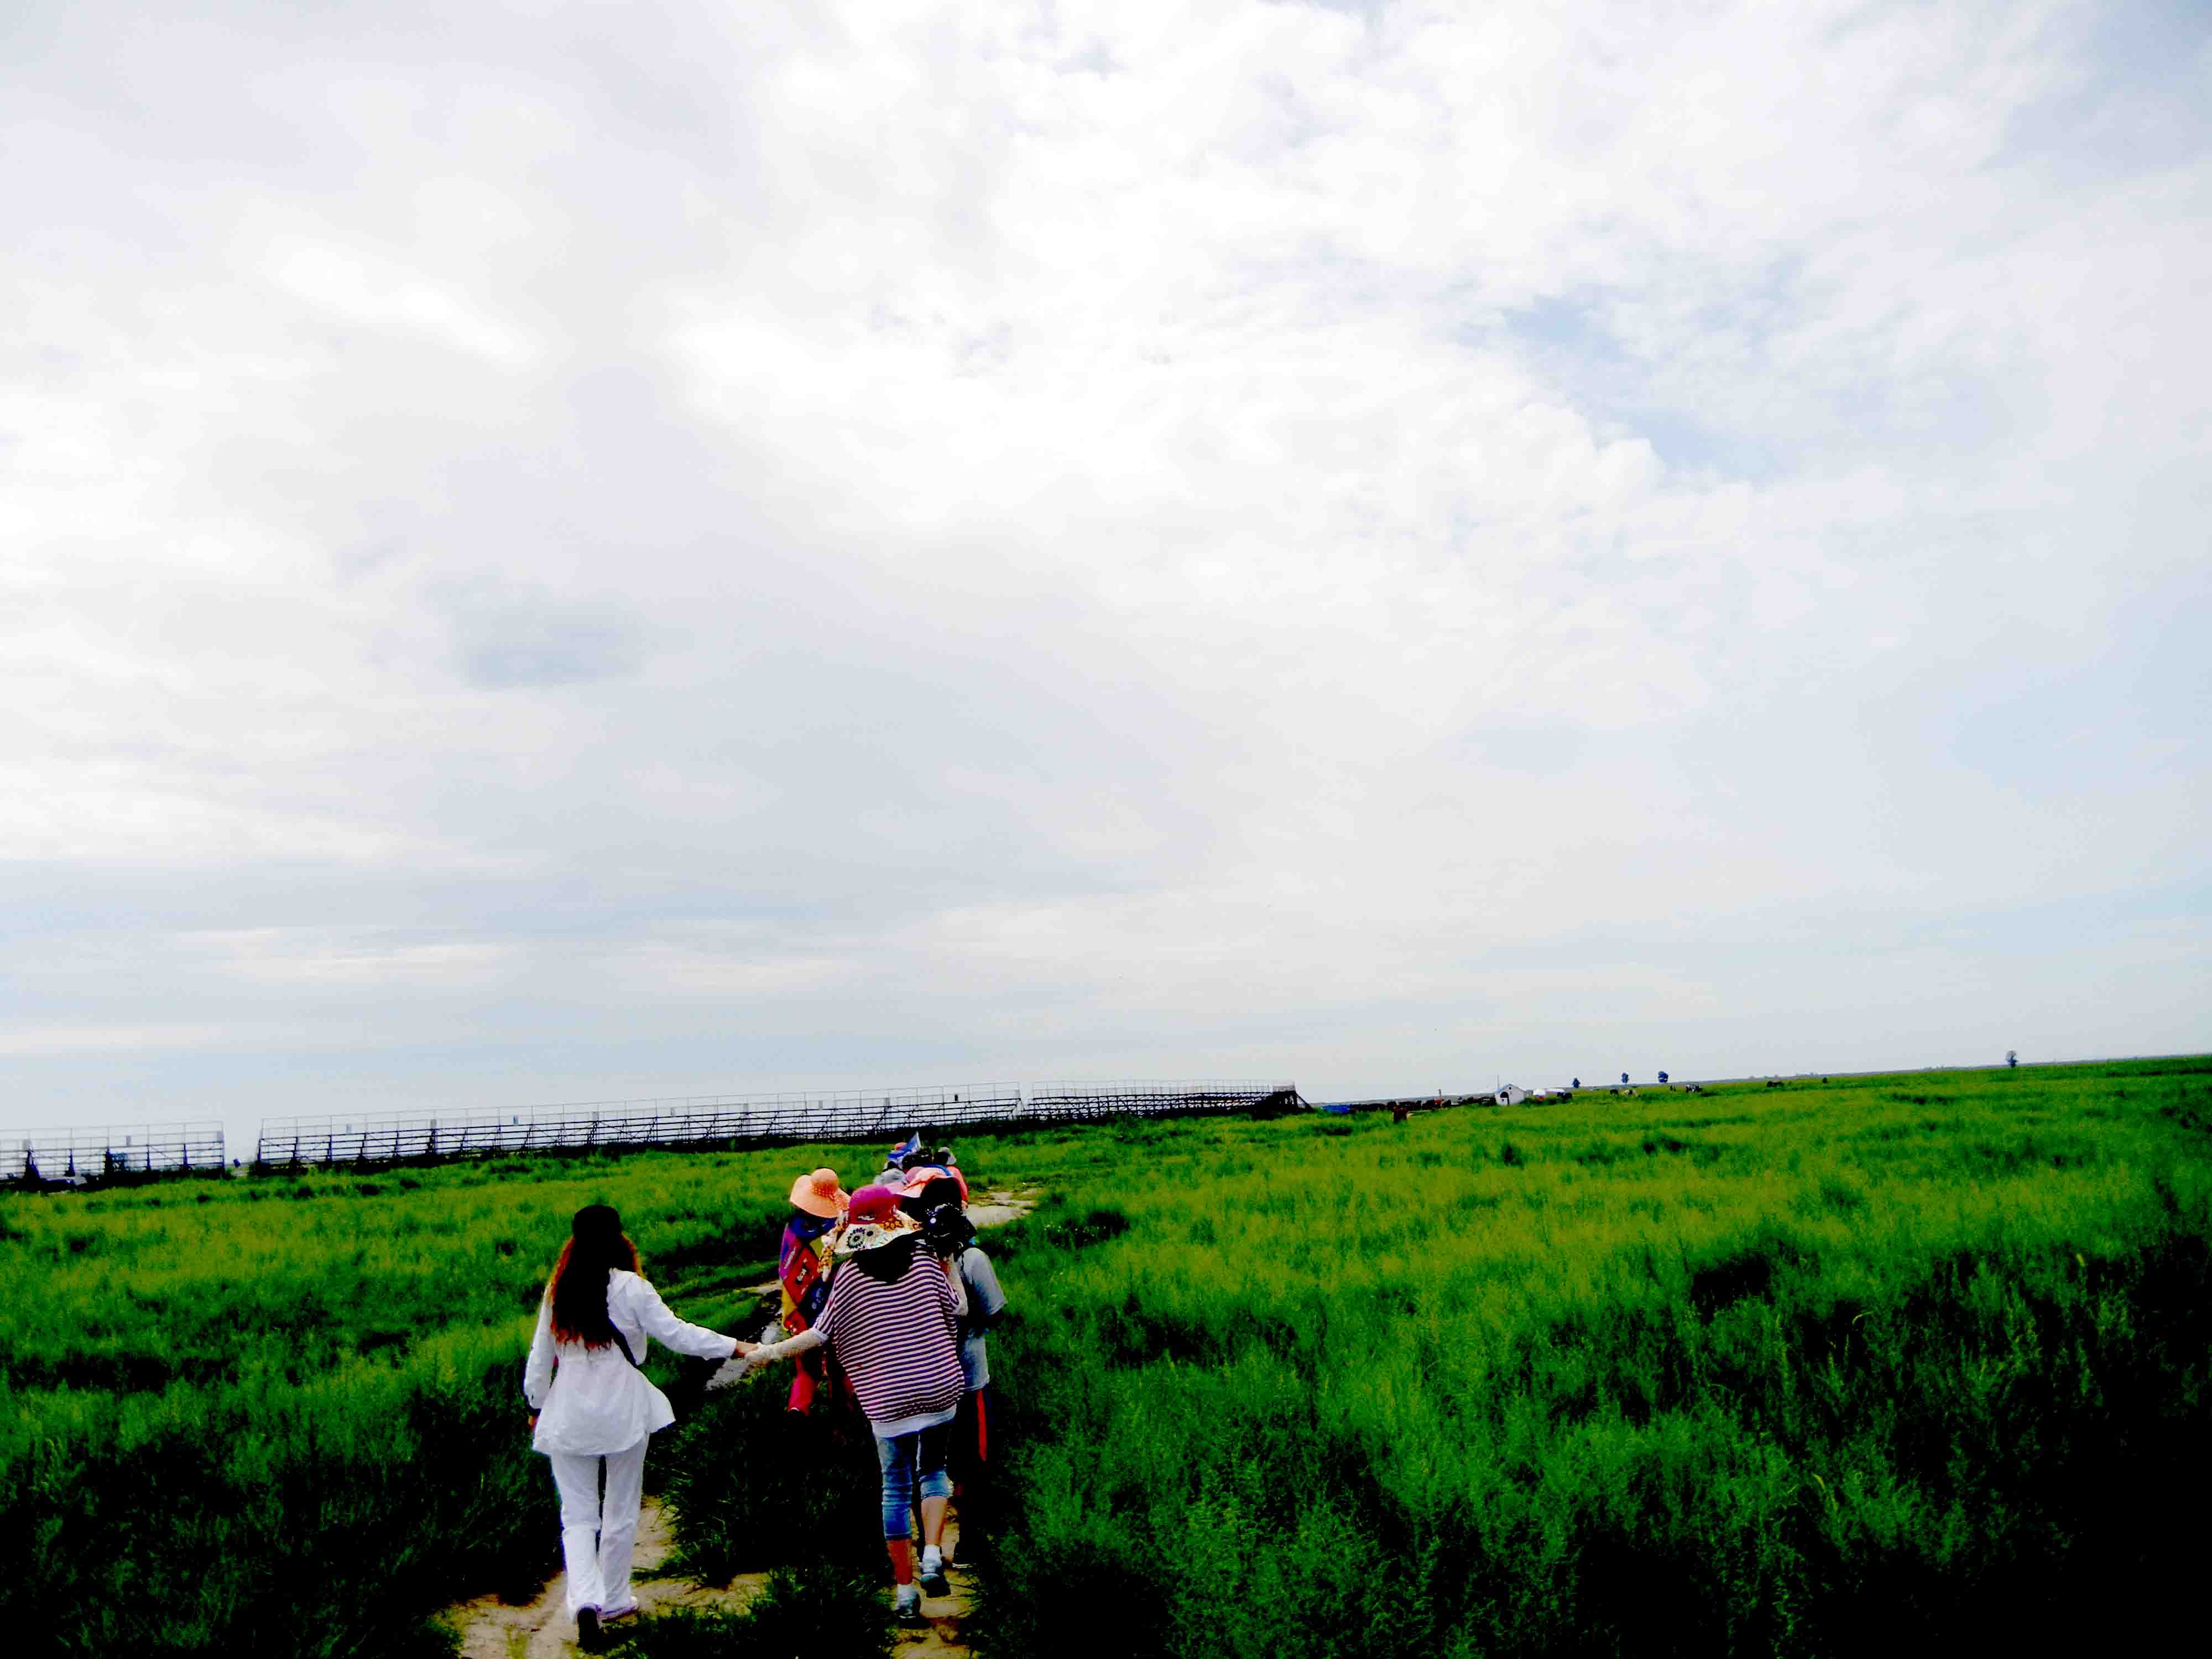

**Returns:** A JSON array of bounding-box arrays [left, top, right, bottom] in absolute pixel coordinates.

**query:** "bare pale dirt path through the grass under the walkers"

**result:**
[[445, 1190, 1040, 1659]]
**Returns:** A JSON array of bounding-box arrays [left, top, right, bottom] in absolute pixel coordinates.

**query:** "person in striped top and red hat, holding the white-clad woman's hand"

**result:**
[[737, 1186, 967, 1626]]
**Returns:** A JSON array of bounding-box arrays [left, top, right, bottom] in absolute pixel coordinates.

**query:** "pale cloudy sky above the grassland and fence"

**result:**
[[0, 0, 2212, 1150]]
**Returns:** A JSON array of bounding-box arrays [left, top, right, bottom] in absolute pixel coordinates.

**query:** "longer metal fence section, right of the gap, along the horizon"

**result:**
[[254, 1082, 1303, 1168]]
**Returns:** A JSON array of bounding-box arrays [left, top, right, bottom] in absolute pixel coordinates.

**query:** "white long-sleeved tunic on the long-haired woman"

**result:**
[[522, 1267, 737, 1458]]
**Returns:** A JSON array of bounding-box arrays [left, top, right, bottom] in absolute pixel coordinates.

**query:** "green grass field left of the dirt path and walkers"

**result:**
[[0, 1148, 821, 1657]]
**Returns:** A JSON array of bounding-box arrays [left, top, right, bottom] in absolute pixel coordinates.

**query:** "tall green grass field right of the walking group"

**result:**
[[947, 1064, 2212, 1657]]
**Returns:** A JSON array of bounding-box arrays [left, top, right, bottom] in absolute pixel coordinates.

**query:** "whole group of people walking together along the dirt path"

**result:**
[[522, 1139, 1006, 1648]]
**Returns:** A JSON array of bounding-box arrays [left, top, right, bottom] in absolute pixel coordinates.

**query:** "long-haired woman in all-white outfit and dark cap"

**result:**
[[522, 1203, 737, 1648]]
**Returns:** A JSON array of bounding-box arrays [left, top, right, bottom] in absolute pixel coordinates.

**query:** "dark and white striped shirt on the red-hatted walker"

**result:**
[[816, 1250, 967, 1433]]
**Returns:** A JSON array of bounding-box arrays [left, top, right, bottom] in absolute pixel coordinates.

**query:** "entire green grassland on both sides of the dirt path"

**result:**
[[0, 1060, 2212, 1657]]
